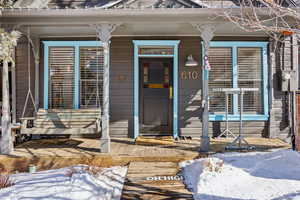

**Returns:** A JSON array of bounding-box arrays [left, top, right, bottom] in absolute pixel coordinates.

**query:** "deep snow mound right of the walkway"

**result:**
[[180, 150, 300, 200]]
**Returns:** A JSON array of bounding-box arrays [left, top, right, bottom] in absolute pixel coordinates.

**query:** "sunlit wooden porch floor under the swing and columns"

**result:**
[[0, 138, 290, 171]]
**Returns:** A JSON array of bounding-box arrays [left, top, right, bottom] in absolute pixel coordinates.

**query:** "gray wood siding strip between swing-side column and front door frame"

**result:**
[[110, 37, 134, 137]]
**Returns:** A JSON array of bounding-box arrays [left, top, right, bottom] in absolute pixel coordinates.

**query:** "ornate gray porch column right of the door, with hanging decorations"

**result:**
[[193, 24, 216, 152]]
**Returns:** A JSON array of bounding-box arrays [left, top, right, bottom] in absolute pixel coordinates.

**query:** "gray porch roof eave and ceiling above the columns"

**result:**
[[0, 8, 284, 37]]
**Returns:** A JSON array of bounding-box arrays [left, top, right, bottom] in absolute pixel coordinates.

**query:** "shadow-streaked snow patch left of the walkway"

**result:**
[[0, 165, 127, 200]]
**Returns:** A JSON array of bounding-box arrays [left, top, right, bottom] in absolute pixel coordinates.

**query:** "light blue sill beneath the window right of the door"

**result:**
[[209, 114, 269, 121]]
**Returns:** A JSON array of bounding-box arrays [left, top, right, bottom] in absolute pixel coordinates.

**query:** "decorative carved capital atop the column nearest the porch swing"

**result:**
[[91, 23, 120, 43]]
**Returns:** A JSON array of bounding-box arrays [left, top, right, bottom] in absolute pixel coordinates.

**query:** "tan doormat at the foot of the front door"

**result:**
[[135, 136, 175, 146]]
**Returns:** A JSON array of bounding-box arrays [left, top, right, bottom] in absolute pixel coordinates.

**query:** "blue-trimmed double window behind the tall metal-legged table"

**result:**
[[209, 42, 269, 121]]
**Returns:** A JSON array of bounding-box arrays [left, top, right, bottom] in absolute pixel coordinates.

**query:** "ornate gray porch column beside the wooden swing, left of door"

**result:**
[[95, 24, 118, 153]]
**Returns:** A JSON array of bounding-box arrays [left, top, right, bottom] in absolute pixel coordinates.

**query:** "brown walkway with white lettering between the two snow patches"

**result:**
[[121, 162, 193, 200]]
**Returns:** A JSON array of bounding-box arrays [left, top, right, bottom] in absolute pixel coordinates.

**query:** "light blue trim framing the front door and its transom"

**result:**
[[132, 40, 180, 138]]
